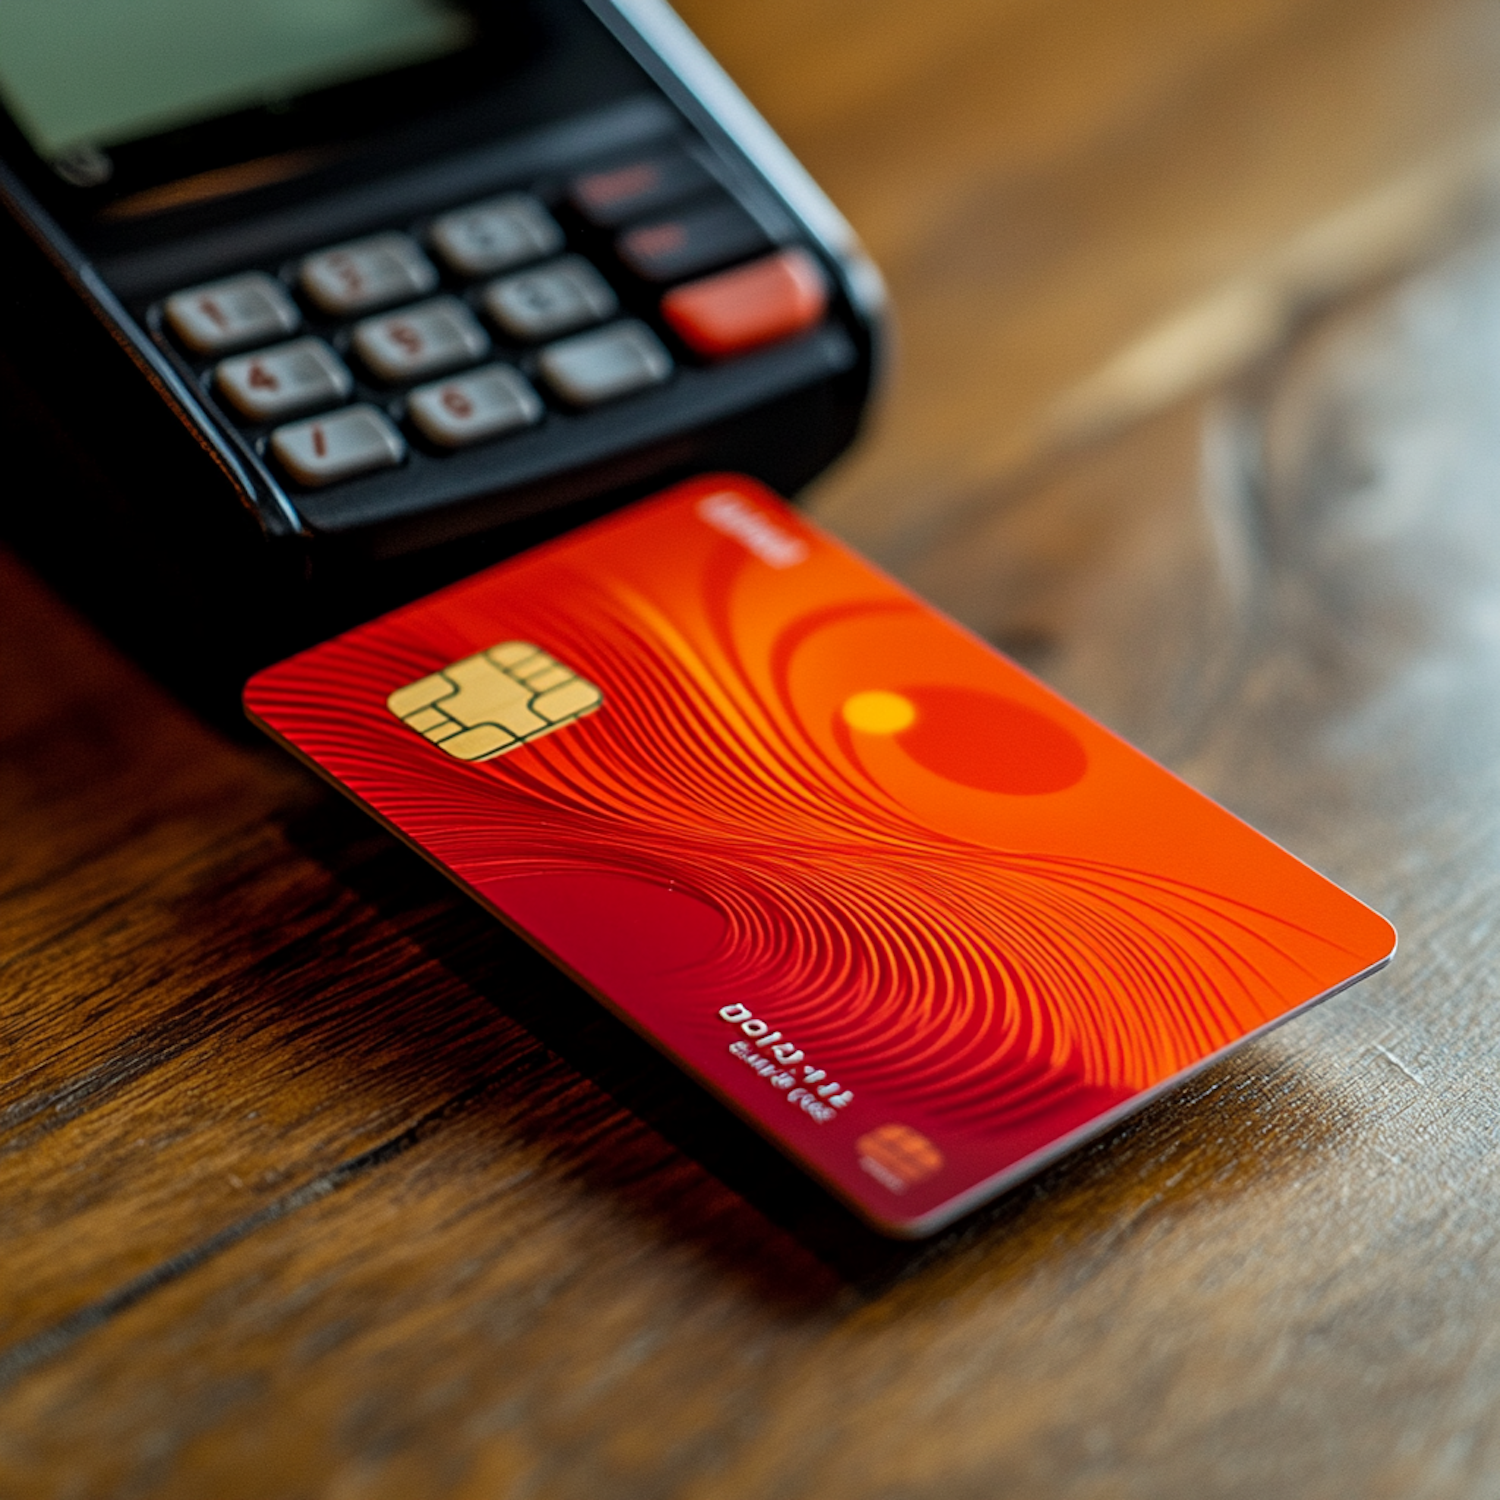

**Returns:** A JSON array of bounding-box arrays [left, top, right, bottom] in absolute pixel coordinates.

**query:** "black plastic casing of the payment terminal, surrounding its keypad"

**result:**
[[0, 0, 882, 704]]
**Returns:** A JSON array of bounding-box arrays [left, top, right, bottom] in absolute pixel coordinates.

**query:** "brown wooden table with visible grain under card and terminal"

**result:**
[[0, 0, 1500, 1500]]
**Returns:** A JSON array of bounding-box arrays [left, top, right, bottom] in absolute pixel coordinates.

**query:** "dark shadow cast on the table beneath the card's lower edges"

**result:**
[[287, 795, 1356, 1316]]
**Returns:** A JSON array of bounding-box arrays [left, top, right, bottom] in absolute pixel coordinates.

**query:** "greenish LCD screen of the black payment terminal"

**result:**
[[0, 0, 476, 158]]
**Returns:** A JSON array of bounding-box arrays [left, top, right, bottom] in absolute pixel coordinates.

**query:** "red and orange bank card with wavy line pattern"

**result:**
[[245, 476, 1395, 1235]]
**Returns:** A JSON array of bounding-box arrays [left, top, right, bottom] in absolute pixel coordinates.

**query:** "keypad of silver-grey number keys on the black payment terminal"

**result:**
[[159, 155, 840, 488]]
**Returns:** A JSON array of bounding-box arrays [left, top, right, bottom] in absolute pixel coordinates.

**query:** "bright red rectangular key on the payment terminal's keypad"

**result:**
[[662, 249, 828, 359]]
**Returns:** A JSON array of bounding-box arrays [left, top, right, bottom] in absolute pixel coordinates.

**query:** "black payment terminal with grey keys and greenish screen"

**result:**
[[0, 0, 881, 675]]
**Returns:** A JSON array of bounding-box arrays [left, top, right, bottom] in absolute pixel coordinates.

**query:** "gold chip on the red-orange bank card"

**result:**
[[386, 641, 605, 761]]
